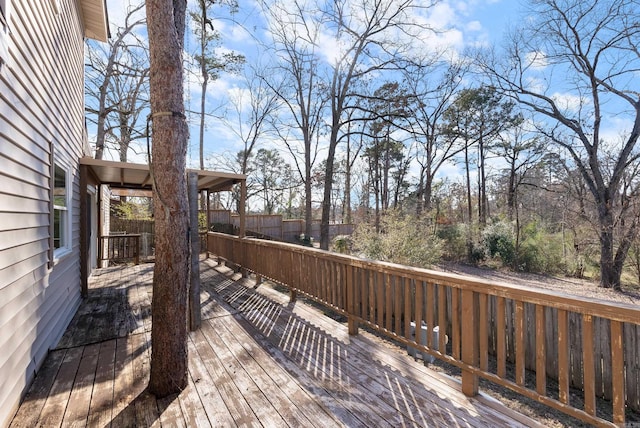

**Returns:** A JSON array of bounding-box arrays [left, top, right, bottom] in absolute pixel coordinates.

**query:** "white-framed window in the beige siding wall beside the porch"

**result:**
[[53, 163, 71, 254]]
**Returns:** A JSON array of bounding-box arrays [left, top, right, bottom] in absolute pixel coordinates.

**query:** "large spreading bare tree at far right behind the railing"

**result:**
[[481, 0, 640, 289]]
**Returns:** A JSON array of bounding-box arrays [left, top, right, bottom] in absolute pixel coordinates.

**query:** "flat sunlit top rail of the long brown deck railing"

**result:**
[[209, 232, 640, 324]]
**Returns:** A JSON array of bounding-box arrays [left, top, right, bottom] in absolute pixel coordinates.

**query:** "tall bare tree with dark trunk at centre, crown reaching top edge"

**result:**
[[320, 0, 438, 249]]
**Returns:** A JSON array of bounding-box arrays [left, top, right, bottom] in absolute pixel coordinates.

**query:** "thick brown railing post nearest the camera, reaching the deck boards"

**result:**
[[462, 289, 478, 397]]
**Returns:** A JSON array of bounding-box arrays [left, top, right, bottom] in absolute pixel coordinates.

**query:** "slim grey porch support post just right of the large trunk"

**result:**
[[187, 172, 202, 331]]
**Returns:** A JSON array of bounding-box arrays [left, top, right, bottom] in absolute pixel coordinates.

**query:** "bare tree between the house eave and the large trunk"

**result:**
[[85, 2, 146, 159]]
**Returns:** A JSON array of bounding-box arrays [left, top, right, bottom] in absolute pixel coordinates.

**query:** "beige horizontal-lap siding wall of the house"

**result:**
[[0, 0, 86, 426]]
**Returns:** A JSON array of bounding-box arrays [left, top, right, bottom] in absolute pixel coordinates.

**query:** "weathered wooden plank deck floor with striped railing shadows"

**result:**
[[11, 260, 537, 427]]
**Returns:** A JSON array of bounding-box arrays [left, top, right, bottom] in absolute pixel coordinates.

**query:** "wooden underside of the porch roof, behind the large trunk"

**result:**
[[80, 157, 247, 192]]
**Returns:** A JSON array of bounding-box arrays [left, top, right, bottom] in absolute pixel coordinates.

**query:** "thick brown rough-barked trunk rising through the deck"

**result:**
[[146, 0, 189, 397]]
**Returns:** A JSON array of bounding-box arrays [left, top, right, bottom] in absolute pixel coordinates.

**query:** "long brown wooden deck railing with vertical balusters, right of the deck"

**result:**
[[208, 233, 640, 426]]
